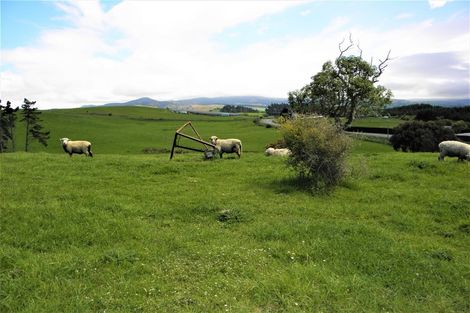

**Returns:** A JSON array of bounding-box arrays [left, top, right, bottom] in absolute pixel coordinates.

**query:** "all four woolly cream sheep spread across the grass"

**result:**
[[60, 136, 470, 161]]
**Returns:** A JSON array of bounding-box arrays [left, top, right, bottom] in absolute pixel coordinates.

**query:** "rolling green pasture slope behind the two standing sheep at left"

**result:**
[[11, 107, 279, 155]]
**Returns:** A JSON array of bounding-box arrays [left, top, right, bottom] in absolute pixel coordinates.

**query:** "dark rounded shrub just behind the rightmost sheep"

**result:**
[[390, 121, 455, 152]]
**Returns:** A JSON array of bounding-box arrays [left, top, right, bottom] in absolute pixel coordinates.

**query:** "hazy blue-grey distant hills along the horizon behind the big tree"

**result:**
[[84, 96, 470, 109]]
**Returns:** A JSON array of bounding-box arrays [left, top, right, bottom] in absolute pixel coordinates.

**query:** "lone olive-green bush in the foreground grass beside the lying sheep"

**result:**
[[282, 118, 351, 190]]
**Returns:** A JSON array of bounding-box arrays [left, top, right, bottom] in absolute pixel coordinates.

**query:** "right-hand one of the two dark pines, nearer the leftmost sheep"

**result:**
[[21, 98, 50, 151]]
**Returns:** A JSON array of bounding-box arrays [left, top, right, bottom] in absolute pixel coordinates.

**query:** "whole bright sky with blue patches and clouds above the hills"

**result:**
[[0, 0, 470, 109]]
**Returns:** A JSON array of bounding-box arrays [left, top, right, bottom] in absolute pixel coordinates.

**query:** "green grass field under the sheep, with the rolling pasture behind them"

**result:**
[[0, 108, 470, 312]]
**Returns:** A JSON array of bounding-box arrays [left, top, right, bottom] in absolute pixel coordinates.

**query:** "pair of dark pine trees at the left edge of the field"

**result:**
[[0, 98, 50, 153]]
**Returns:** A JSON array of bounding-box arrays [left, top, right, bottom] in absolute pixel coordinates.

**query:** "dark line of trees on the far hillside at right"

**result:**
[[384, 103, 470, 122]]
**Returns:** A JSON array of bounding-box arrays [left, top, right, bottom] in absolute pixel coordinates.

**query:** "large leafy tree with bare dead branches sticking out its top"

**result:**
[[288, 37, 392, 128]]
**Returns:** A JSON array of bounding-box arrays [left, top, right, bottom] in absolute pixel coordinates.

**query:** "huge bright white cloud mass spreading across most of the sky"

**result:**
[[0, 1, 470, 108]]
